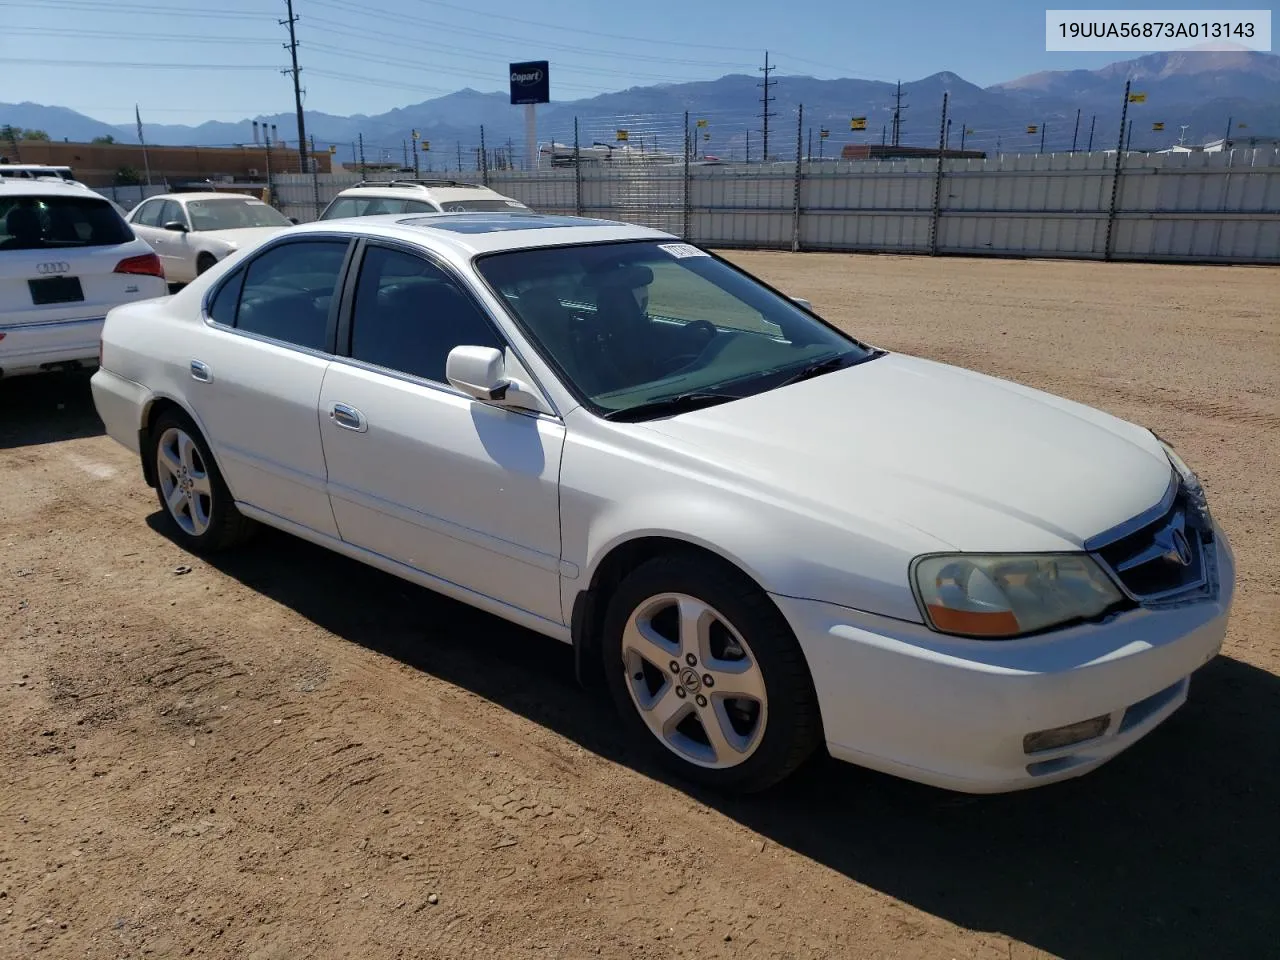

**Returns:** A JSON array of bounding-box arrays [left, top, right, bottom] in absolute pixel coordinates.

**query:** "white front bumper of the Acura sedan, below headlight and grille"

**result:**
[[773, 530, 1235, 794]]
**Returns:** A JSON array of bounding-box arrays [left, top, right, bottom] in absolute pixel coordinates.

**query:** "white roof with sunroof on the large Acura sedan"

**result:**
[[288, 210, 680, 257]]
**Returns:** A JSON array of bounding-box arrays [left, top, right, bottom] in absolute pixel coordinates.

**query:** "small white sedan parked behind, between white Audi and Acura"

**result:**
[[125, 191, 294, 283]]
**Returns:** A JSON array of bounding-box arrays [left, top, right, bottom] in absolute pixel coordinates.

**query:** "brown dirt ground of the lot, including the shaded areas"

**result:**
[[0, 253, 1280, 960]]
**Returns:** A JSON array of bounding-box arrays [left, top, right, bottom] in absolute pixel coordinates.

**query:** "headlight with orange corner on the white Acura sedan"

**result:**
[[911, 553, 1124, 639]]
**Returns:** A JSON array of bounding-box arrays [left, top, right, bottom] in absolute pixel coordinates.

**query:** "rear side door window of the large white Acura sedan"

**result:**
[[235, 239, 347, 349]]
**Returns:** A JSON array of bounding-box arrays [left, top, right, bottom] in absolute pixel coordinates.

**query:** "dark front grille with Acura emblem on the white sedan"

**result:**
[[1097, 484, 1212, 602]]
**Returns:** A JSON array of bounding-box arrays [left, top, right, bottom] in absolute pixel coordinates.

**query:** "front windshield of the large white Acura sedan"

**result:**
[[476, 241, 876, 416]]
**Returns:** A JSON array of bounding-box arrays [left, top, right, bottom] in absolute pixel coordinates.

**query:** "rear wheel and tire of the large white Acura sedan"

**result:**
[[147, 410, 255, 554]]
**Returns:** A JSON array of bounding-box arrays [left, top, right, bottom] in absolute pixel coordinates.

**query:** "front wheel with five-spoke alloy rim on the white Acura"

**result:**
[[602, 556, 822, 794]]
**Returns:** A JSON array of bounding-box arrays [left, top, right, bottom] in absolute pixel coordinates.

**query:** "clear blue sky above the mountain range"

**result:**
[[0, 0, 1265, 123]]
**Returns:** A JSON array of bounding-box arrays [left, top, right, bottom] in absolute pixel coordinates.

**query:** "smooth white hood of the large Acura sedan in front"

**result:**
[[636, 355, 1172, 550]]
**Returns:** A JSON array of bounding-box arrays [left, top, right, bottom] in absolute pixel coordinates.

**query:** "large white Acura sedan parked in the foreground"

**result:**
[[92, 212, 1235, 792]]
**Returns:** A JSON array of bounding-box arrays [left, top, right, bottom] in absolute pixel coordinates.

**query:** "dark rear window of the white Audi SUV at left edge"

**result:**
[[0, 195, 133, 250]]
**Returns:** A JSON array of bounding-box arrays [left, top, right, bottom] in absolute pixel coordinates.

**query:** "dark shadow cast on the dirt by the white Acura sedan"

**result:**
[[148, 512, 1280, 960]]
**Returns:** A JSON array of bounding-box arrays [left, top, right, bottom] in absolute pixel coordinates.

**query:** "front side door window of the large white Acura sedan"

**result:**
[[351, 246, 507, 383]]
